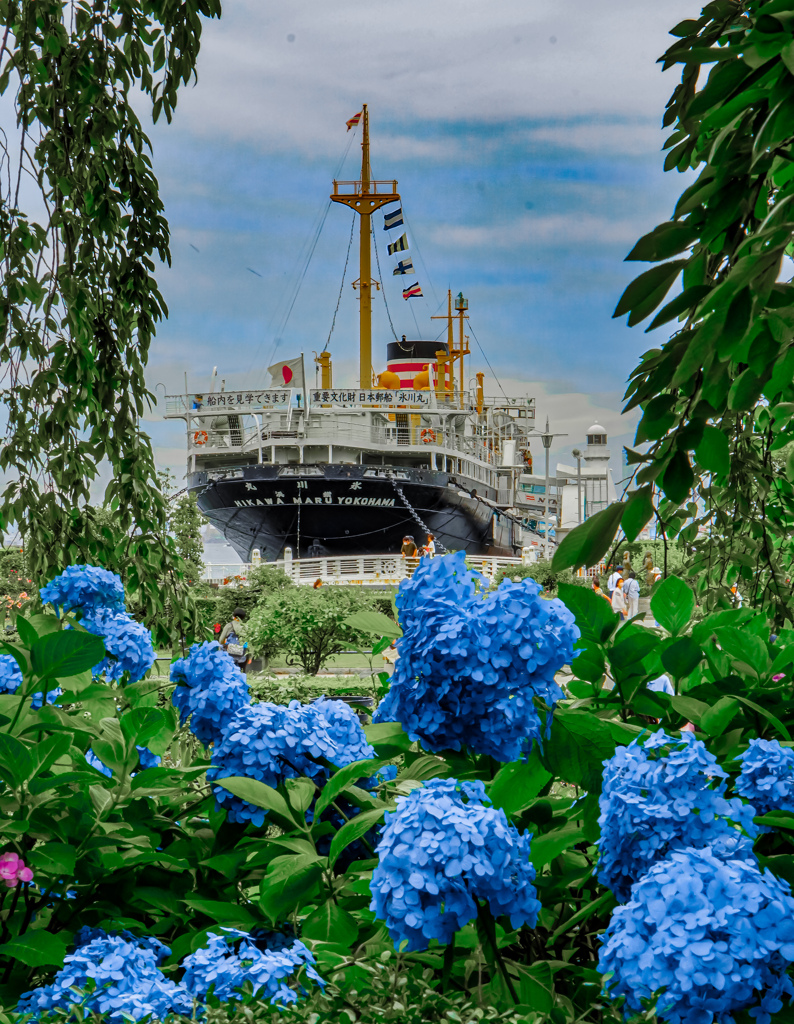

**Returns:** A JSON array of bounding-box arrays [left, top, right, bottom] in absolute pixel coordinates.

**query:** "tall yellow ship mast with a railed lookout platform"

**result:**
[[331, 103, 400, 387]]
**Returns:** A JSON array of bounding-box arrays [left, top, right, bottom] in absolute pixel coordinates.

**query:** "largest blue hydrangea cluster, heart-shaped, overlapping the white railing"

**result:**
[[374, 552, 580, 761]]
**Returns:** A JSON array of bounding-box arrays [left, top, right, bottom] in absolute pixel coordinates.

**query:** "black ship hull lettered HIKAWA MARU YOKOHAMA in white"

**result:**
[[187, 465, 520, 562]]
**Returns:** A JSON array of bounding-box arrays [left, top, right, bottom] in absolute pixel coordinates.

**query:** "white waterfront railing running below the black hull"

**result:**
[[203, 547, 537, 588]]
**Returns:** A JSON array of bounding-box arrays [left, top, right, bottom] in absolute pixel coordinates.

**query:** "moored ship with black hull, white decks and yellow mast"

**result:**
[[165, 105, 535, 562]]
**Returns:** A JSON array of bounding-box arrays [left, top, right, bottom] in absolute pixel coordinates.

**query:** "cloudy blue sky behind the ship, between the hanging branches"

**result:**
[[141, 0, 700, 557]]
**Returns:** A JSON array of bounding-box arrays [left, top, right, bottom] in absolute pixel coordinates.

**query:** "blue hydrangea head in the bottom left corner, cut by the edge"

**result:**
[[16, 929, 193, 1024]]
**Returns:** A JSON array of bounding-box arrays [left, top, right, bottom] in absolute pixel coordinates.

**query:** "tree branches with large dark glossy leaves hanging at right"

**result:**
[[556, 0, 794, 622]]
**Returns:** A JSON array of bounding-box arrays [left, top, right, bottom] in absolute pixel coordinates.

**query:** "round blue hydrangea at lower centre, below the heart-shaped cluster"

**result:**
[[370, 778, 540, 950]]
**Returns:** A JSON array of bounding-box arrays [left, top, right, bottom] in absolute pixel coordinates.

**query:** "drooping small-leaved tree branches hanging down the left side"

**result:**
[[0, 0, 220, 639]]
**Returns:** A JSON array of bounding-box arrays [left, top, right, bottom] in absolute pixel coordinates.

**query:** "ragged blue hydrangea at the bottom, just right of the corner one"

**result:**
[[182, 928, 325, 1006]]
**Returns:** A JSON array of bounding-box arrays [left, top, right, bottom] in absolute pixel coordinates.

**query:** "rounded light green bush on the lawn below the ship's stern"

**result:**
[[245, 587, 382, 676]]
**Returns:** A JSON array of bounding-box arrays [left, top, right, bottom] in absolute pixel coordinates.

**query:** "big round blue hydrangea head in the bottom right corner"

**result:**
[[598, 846, 794, 1024]]
